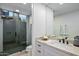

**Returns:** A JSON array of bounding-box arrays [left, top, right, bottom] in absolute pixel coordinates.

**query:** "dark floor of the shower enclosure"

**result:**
[[0, 44, 26, 56]]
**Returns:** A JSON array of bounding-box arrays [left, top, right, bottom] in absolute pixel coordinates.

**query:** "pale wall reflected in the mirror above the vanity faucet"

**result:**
[[54, 11, 79, 37]]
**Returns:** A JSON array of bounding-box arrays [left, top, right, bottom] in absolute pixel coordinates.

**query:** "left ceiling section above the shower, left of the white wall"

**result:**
[[0, 3, 31, 15]]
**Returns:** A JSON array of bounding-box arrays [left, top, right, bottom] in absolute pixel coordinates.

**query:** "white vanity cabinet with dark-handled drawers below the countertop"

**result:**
[[35, 41, 74, 56]]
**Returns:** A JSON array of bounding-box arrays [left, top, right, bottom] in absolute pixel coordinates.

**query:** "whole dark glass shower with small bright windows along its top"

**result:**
[[0, 9, 29, 55]]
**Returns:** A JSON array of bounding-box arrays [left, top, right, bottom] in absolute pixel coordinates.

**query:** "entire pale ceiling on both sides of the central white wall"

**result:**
[[0, 3, 79, 16]]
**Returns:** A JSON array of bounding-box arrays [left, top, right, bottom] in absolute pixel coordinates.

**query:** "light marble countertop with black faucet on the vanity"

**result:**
[[37, 39, 79, 56]]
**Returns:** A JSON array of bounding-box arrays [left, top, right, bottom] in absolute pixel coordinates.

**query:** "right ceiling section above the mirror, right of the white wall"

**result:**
[[44, 3, 79, 16]]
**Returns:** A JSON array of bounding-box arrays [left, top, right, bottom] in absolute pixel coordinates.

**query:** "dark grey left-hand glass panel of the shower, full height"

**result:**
[[3, 19, 16, 51]]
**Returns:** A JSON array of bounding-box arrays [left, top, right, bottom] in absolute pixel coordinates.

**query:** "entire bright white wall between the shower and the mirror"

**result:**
[[32, 4, 53, 55]]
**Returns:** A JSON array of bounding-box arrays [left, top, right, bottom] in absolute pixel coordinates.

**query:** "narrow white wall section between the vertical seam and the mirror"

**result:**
[[46, 7, 53, 35]]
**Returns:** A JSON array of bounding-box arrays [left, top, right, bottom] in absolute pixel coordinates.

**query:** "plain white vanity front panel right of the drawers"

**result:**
[[44, 45, 73, 56]]
